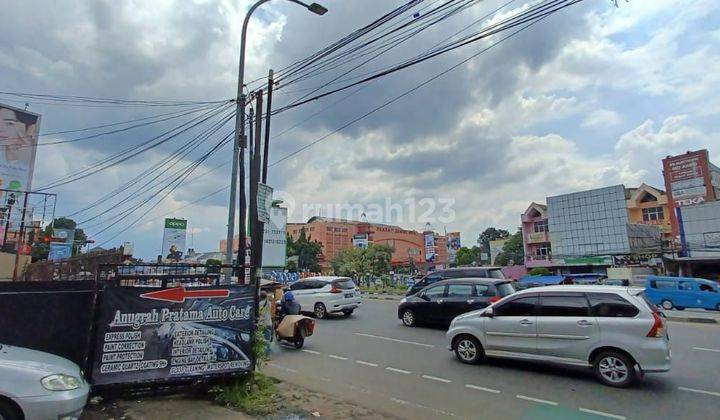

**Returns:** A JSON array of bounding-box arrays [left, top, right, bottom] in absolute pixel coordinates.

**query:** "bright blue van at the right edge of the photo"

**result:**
[[645, 276, 720, 311]]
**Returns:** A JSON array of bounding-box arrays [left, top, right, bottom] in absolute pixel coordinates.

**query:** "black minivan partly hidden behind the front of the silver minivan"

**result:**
[[398, 278, 515, 327]]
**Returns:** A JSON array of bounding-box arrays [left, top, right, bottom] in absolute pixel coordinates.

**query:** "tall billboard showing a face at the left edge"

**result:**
[[0, 104, 40, 200]]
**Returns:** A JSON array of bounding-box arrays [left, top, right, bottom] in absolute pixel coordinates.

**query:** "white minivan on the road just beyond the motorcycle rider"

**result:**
[[290, 276, 362, 319]]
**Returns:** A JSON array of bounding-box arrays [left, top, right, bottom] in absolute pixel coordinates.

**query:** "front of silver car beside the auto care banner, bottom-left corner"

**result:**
[[0, 344, 90, 420]]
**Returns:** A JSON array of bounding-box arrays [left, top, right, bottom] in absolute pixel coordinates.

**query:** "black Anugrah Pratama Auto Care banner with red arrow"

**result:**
[[91, 285, 256, 385]]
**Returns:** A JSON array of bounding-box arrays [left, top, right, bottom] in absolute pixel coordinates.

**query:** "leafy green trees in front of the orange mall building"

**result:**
[[331, 244, 394, 278]]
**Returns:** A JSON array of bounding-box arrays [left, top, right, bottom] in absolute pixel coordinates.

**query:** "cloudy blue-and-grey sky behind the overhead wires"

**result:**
[[0, 0, 720, 257]]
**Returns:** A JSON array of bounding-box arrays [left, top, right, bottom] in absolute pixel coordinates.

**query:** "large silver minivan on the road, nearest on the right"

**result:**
[[446, 285, 670, 387]]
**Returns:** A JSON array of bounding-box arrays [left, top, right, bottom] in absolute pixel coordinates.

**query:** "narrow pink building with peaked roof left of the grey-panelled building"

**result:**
[[520, 203, 554, 269]]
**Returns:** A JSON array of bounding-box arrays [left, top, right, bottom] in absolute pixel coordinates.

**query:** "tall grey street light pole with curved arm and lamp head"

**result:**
[[225, 0, 327, 282]]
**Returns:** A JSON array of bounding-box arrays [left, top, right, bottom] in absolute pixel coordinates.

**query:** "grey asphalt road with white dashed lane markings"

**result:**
[[266, 300, 720, 419]]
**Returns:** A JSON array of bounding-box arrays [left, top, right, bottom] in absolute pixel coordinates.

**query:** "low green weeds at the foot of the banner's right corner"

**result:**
[[211, 372, 277, 416]]
